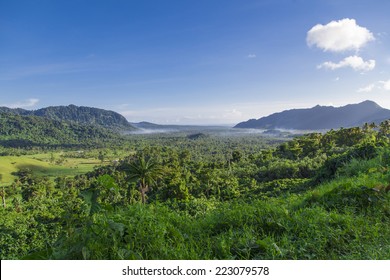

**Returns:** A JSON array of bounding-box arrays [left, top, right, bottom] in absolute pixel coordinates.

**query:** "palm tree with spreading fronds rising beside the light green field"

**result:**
[[129, 156, 162, 203]]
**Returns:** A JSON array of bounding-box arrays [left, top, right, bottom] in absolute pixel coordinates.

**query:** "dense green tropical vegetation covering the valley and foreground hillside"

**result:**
[[0, 121, 390, 259]]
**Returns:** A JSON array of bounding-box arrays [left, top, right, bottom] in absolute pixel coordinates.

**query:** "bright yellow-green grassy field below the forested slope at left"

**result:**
[[0, 152, 101, 185]]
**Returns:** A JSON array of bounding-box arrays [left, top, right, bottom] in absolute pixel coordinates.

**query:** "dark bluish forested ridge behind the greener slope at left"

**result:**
[[0, 105, 135, 130]]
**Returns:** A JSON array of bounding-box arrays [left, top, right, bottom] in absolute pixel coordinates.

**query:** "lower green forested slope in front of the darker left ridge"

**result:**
[[0, 113, 120, 147]]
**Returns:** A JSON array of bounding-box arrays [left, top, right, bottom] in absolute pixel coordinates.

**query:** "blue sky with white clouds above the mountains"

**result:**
[[0, 0, 390, 125]]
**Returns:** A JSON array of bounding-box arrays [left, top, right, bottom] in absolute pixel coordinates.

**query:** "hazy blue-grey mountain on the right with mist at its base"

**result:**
[[235, 100, 390, 130]]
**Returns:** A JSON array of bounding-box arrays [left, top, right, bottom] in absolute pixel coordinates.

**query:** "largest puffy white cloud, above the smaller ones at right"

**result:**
[[306, 18, 375, 52]]
